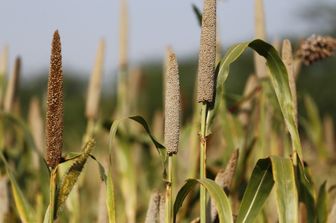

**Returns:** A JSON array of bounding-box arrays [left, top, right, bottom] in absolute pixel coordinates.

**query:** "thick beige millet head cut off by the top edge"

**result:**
[[197, 0, 216, 103]]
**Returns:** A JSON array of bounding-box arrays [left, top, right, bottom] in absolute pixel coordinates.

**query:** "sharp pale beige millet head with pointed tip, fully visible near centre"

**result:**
[[164, 49, 181, 155]]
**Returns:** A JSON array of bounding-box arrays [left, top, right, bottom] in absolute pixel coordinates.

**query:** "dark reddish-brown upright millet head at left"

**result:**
[[46, 30, 64, 168]]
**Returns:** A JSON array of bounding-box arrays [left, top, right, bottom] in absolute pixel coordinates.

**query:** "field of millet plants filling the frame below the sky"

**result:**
[[0, 0, 336, 223]]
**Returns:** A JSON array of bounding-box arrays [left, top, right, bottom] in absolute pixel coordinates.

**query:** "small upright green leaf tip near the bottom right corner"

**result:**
[[316, 181, 328, 223]]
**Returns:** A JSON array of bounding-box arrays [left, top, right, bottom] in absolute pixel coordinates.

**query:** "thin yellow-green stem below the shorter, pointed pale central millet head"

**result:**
[[165, 155, 173, 223]]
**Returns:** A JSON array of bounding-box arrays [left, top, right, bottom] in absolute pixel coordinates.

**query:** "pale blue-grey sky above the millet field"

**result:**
[[0, 0, 336, 77]]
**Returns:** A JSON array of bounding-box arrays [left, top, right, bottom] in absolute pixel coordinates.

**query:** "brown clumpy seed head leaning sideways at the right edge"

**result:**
[[297, 35, 336, 65]]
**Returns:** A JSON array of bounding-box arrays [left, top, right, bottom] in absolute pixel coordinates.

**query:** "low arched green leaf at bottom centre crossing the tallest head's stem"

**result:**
[[174, 179, 233, 223]]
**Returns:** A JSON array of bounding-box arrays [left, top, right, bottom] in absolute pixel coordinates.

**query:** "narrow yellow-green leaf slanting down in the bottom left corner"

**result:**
[[0, 151, 35, 223]]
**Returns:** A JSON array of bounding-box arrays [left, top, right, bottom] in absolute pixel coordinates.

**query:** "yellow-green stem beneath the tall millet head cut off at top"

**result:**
[[200, 103, 208, 223]]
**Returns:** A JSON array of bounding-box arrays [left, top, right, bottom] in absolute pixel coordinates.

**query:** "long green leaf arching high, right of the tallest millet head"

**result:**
[[212, 39, 302, 158]]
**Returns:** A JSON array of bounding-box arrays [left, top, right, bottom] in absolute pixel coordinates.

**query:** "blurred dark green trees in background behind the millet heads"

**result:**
[[20, 2, 336, 150]]
